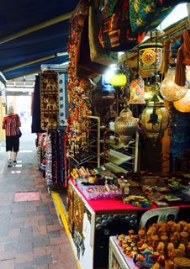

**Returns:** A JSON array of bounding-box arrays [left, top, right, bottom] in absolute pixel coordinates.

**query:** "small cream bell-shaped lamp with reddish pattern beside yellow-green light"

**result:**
[[129, 75, 145, 104]]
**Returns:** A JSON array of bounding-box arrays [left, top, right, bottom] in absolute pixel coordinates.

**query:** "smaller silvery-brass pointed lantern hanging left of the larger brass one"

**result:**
[[114, 104, 138, 144]]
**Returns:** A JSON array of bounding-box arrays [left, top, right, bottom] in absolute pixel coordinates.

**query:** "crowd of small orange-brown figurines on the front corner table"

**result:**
[[118, 221, 190, 269]]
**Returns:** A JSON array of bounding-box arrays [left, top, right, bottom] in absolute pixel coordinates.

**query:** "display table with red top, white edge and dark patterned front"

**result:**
[[68, 180, 190, 269]]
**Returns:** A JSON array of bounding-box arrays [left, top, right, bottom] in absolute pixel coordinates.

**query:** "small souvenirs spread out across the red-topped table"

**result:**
[[71, 166, 190, 209]]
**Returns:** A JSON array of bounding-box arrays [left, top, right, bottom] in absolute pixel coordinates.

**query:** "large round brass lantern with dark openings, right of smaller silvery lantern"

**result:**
[[140, 94, 169, 139]]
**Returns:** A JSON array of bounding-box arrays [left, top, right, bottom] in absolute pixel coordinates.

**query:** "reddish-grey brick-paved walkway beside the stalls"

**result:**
[[0, 133, 78, 269]]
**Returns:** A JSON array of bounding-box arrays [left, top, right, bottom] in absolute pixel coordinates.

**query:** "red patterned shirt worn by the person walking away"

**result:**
[[2, 114, 21, 136]]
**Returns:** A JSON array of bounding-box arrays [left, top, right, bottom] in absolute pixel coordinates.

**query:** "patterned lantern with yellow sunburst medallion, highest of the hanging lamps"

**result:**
[[139, 42, 163, 76]]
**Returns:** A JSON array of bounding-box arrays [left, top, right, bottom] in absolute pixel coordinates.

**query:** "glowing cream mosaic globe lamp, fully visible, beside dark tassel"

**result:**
[[160, 68, 187, 102]]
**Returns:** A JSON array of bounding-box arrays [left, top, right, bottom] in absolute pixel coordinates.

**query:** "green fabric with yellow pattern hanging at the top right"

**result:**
[[129, 0, 174, 34]]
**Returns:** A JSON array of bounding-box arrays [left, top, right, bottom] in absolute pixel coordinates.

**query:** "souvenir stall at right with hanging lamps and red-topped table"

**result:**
[[59, 1, 190, 269]]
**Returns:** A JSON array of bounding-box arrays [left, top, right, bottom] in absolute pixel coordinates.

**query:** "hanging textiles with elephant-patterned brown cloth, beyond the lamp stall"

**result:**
[[32, 66, 68, 190]]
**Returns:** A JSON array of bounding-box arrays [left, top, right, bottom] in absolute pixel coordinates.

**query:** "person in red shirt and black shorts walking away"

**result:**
[[2, 106, 21, 167]]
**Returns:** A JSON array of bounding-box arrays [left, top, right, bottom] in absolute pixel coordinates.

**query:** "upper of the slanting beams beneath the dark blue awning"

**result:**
[[0, 12, 73, 45]]
